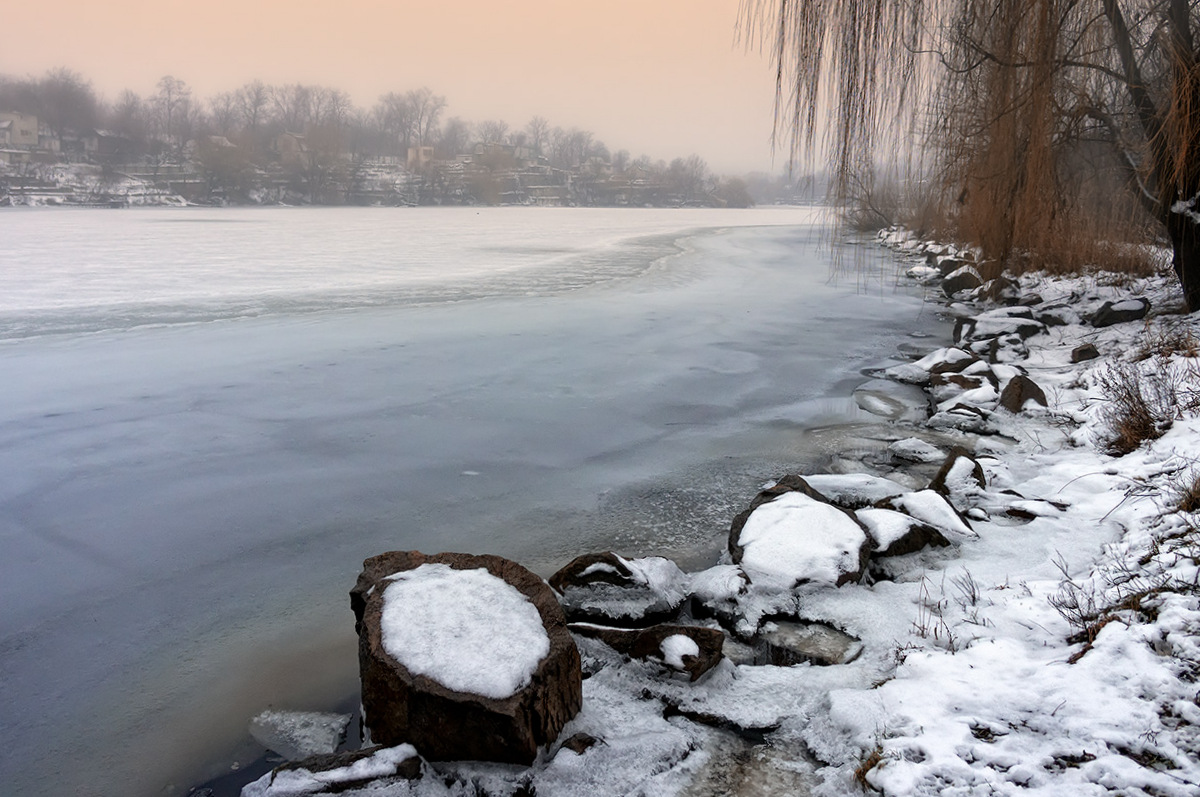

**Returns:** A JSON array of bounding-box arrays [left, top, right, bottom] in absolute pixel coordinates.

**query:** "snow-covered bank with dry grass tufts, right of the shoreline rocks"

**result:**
[[244, 230, 1200, 796]]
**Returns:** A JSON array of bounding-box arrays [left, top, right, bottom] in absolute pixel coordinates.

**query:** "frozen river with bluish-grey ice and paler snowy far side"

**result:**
[[0, 208, 936, 797]]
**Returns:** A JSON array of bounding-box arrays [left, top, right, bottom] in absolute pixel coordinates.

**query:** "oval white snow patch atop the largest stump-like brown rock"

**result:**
[[382, 564, 550, 700]]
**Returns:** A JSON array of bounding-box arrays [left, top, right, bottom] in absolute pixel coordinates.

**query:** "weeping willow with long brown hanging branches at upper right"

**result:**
[[743, 0, 1200, 311]]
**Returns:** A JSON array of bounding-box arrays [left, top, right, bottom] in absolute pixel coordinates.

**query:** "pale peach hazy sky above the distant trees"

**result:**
[[0, 0, 786, 173]]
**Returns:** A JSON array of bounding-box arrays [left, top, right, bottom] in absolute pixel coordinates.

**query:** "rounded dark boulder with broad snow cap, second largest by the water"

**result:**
[[730, 475, 871, 589]]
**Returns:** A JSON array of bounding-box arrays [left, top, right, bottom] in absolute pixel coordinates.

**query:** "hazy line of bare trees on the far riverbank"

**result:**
[[0, 68, 821, 206]]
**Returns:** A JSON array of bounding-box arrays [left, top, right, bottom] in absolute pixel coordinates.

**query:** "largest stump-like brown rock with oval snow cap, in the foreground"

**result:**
[[350, 551, 583, 765]]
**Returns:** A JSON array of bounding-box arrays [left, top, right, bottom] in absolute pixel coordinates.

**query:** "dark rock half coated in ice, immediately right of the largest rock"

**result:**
[[550, 552, 688, 627]]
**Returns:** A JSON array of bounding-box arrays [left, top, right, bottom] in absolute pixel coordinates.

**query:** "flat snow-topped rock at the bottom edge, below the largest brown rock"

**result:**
[[241, 744, 421, 797]]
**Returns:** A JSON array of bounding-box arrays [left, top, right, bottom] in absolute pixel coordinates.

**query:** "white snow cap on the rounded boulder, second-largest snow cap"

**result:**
[[738, 492, 866, 587]]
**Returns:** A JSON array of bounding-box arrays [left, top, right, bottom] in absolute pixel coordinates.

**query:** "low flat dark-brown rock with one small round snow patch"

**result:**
[[570, 623, 725, 681]]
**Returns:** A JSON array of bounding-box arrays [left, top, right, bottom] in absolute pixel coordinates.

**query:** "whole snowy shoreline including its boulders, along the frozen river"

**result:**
[[208, 233, 1200, 797]]
